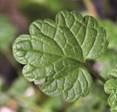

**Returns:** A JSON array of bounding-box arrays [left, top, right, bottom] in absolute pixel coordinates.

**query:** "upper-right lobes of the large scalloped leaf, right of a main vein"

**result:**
[[56, 11, 108, 59]]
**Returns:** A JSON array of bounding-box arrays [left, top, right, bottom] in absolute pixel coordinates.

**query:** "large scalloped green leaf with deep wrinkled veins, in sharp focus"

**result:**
[[13, 11, 108, 102]]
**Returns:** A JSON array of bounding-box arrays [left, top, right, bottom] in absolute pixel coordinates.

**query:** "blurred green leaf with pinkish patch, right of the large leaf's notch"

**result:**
[[95, 49, 117, 80]]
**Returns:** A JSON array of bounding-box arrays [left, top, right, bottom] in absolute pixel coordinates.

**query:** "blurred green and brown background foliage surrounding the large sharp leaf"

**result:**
[[0, 0, 117, 112]]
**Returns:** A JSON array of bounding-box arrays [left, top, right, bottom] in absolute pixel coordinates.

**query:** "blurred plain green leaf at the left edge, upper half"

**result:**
[[0, 15, 16, 50]]
